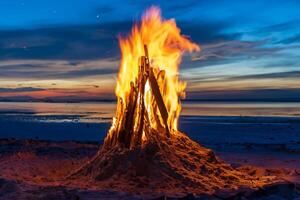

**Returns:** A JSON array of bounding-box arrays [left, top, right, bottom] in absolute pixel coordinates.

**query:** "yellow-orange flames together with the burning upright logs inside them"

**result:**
[[106, 7, 200, 148]]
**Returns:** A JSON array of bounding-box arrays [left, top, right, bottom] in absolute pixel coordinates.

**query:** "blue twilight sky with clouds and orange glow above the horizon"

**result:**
[[0, 0, 300, 101]]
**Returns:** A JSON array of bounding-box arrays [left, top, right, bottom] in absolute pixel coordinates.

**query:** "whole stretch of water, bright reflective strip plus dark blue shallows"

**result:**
[[0, 102, 300, 142]]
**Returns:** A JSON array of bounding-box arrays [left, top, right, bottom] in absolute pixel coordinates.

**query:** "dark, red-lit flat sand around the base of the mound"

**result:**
[[0, 139, 300, 200]]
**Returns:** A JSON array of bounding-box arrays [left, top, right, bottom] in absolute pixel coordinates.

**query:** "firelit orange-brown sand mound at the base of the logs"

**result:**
[[71, 132, 270, 195]]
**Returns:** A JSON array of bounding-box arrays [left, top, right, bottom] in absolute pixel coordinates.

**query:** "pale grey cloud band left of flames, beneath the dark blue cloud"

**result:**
[[0, 59, 119, 80]]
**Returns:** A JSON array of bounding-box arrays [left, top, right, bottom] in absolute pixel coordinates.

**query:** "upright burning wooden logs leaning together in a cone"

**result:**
[[105, 45, 170, 148]]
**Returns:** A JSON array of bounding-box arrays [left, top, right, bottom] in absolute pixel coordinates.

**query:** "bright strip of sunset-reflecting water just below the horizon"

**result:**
[[0, 102, 300, 122]]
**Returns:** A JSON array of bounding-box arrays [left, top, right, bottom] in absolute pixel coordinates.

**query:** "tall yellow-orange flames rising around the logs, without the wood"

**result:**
[[116, 7, 200, 133]]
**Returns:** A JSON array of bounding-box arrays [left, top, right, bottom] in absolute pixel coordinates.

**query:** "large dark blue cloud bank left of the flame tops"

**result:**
[[0, 21, 131, 60]]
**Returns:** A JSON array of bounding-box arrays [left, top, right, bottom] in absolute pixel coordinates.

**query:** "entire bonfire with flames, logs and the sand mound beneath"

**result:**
[[72, 7, 274, 197]]
